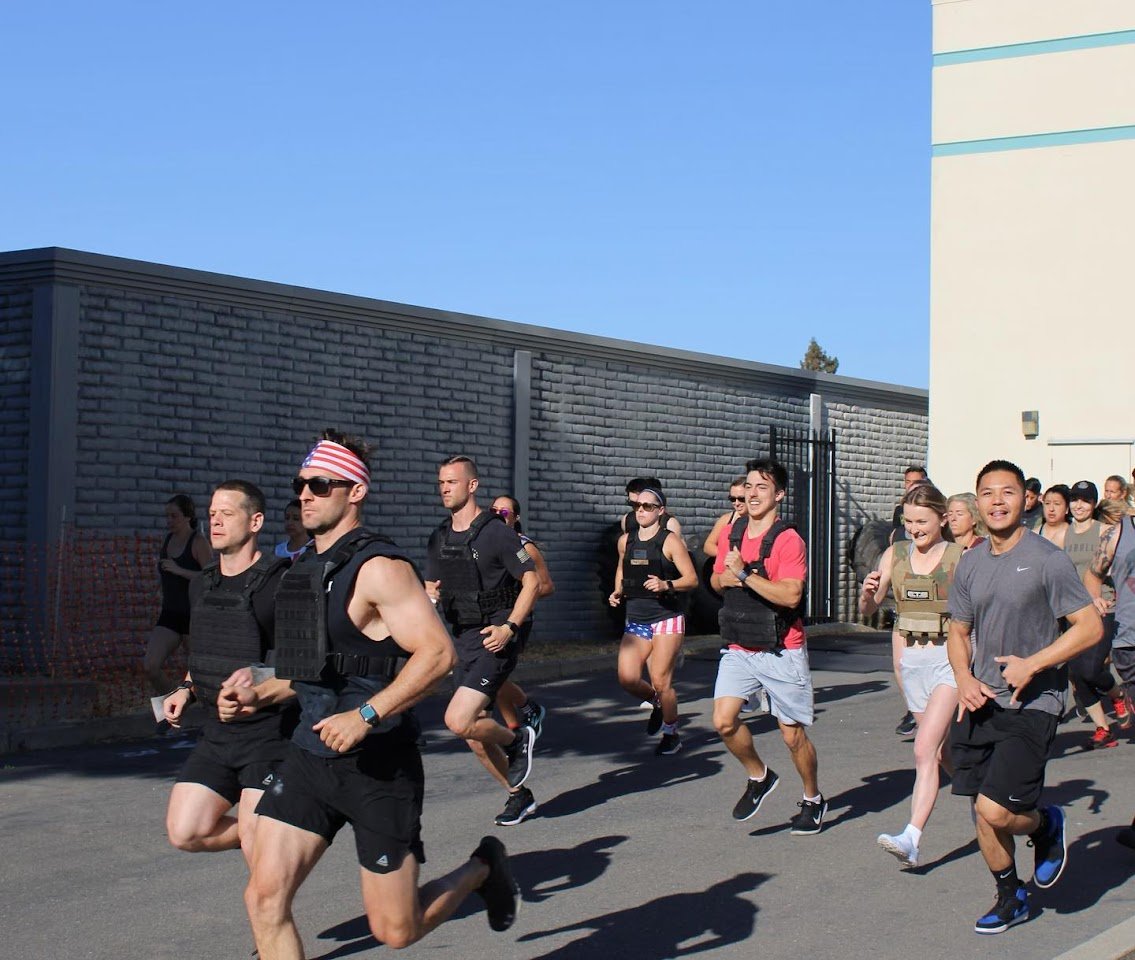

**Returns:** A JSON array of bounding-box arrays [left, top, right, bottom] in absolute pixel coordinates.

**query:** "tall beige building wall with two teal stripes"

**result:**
[[930, 0, 1135, 494]]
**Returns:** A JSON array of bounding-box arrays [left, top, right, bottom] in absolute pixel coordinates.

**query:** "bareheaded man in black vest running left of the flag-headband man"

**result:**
[[165, 480, 296, 860]]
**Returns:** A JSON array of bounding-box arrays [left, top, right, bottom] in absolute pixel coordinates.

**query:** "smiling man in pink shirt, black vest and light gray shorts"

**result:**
[[712, 460, 827, 835]]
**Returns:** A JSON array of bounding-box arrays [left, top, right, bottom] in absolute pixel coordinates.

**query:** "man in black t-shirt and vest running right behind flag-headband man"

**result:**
[[426, 456, 539, 826]]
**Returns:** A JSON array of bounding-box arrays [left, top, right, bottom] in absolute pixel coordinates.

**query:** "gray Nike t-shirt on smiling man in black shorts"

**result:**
[[949, 530, 1092, 715]]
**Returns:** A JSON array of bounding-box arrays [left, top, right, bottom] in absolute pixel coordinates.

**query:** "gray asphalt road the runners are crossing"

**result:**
[[0, 646, 1135, 960]]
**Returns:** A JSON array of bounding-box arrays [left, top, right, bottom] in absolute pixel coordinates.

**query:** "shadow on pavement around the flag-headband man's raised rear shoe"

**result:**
[[318, 835, 628, 960]]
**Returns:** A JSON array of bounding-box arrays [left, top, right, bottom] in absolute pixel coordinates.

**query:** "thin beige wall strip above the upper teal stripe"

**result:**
[[933, 0, 1135, 53]]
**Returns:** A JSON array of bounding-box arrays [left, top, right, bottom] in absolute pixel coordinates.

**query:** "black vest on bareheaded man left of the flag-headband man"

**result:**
[[190, 554, 288, 706]]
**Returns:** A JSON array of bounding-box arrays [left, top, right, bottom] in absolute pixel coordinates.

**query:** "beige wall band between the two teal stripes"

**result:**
[[932, 45, 1135, 143]]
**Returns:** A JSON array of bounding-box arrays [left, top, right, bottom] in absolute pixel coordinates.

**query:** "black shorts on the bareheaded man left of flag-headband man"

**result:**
[[177, 710, 295, 803]]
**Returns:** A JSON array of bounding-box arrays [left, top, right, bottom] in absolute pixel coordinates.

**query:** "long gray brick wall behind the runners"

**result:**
[[0, 251, 926, 639]]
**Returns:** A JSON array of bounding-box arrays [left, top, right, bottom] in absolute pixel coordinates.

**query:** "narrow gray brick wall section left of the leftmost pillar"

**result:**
[[0, 288, 32, 540]]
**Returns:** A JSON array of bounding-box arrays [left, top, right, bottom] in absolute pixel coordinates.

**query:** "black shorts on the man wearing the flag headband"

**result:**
[[257, 736, 426, 874]]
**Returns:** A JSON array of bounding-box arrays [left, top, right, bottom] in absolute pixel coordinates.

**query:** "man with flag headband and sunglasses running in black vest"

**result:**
[[219, 430, 519, 960]]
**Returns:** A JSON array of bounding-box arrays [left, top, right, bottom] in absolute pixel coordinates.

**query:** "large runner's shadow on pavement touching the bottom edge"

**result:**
[[520, 873, 772, 960]]
